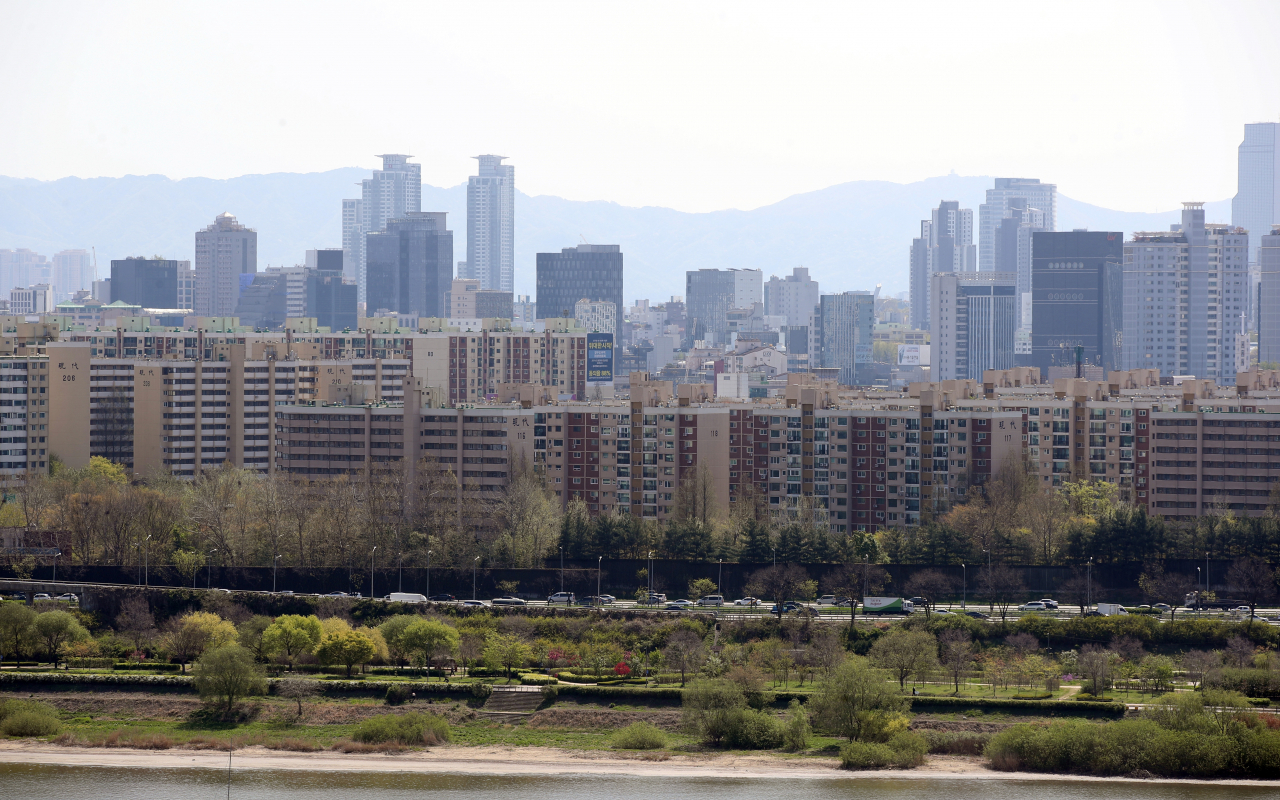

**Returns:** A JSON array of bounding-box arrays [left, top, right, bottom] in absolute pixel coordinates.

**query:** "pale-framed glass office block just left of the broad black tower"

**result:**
[[929, 273, 1018, 380]]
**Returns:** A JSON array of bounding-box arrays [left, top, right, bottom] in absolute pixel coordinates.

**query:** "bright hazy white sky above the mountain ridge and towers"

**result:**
[[0, 0, 1280, 211]]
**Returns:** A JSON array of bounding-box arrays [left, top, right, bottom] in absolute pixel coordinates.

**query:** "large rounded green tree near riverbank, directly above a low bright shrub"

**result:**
[[809, 655, 908, 741]]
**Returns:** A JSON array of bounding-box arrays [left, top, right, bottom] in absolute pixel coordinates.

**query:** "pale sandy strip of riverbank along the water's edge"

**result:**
[[0, 741, 1276, 787]]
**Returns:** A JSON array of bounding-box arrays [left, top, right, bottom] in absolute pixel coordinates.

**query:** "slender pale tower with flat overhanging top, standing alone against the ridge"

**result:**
[[458, 155, 516, 292]]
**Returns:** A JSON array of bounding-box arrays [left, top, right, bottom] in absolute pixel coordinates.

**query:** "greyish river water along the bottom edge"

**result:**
[[0, 764, 1276, 800]]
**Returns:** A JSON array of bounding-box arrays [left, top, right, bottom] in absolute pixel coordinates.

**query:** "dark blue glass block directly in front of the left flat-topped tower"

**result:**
[[365, 211, 453, 317]]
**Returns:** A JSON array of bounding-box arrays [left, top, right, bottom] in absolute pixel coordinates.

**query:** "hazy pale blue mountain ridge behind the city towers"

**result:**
[[0, 168, 1230, 302]]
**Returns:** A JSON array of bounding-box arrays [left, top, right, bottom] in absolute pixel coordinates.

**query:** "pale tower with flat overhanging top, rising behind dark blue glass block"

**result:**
[[342, 154, 422, 302]]
